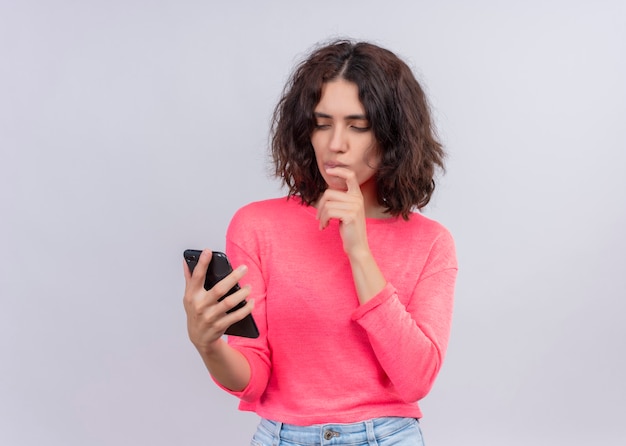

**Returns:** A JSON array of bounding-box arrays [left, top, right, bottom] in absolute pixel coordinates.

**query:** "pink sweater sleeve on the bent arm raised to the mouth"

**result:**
[[352, 232, 457, 402]]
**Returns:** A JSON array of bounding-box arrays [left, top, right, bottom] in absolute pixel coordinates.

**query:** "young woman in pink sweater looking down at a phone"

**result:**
[[184, 40, 457, 446]]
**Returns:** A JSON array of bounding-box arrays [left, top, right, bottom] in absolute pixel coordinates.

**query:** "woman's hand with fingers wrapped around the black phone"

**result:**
[[183, 250, 254, 355]]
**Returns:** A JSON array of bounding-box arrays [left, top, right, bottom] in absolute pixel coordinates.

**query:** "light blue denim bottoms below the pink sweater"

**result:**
[[250, 417, 424, 446]]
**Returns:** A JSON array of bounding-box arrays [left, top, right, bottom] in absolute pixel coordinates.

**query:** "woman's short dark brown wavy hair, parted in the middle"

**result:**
[[270, 40, 445, 219]]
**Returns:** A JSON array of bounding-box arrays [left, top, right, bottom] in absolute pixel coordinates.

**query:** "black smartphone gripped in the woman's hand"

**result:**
[[183, 249, 259, 338]]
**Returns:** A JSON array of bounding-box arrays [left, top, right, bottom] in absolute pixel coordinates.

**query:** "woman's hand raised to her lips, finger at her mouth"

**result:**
[[317, 167, 369, 257]]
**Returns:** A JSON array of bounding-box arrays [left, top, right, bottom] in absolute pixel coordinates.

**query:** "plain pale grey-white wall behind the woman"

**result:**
[[0, 0, 626, 446]]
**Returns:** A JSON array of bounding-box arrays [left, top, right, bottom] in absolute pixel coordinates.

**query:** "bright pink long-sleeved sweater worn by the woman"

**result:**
[[217, 198, 457, 425]]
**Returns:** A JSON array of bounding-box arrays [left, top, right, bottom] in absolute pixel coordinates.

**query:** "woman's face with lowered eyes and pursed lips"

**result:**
[[311, 79, 380, 197]]
